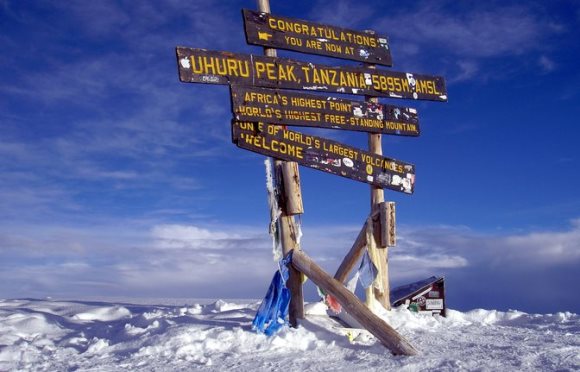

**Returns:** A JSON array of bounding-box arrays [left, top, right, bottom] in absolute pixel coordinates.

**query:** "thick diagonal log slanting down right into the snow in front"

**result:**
[[292, 251, 417, 355]]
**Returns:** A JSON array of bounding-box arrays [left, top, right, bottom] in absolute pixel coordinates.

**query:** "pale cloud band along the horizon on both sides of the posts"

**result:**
[[0, 219, 580, 312]]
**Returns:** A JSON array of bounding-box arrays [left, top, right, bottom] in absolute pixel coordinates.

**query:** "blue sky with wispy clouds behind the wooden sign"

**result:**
[[0, 0, 580, 312]]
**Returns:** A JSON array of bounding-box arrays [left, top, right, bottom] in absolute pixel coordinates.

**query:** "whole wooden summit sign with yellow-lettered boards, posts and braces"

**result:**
[[176, 0, 447, 355]]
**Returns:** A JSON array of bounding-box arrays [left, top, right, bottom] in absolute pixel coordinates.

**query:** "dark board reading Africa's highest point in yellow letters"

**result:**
[[231, 84, 419, 136]]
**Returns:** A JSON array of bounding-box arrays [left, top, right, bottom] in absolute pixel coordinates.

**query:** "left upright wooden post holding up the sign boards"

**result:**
[[258, 0, 304, 327]]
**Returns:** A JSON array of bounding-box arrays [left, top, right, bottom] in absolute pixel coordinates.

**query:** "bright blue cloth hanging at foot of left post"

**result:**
[[252, 253, 292, 336]]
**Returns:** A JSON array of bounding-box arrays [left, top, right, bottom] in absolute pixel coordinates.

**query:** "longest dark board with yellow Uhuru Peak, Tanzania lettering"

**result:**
[[177, 47, 447, 101]]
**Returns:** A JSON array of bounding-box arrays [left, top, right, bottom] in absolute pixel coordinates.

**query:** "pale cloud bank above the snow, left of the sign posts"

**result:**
[[0, 221, 276, 297]]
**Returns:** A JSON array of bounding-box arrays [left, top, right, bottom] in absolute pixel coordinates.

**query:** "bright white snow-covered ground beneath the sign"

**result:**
[[0, 299, 580, 371]]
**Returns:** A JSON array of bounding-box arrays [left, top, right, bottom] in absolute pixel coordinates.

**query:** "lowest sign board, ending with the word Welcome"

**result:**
[[232, 120, 415, 194]]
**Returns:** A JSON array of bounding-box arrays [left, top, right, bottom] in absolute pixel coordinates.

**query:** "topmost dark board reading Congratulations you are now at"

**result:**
[[242, 9, 393, 66]]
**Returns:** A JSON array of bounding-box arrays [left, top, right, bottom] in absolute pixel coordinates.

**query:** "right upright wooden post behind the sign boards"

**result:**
[[365, 64, 391, 310]]
